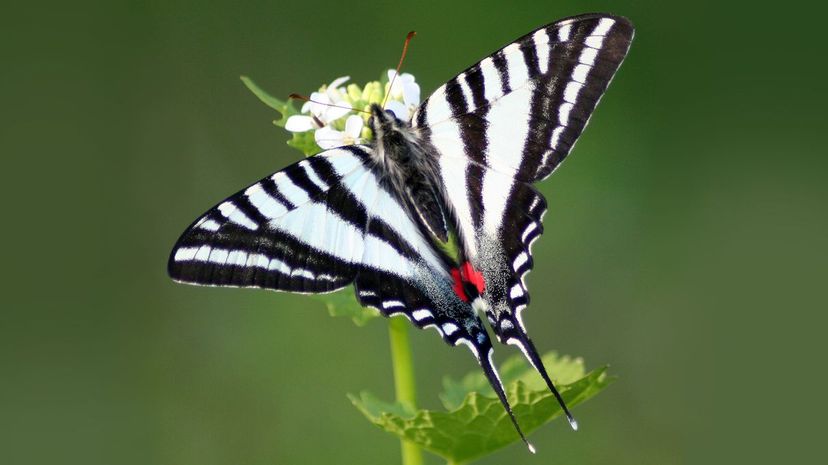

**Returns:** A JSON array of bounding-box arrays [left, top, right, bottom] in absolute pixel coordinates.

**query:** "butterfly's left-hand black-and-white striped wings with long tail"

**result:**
[[168, 146, 532, 442]]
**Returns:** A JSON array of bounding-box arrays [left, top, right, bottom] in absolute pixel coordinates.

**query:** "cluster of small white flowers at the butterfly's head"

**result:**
[[285, 70, 420, 149]]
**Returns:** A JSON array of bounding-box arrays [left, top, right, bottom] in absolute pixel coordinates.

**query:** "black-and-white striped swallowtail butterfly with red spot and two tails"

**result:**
[[169, 14, 633, 444]]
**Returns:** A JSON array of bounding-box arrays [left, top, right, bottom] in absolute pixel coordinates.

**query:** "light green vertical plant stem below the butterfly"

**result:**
[[388, 317, 423, 465]]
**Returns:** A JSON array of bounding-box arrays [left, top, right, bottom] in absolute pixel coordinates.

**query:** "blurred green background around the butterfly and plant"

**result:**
[[0, 0, 828, 465]]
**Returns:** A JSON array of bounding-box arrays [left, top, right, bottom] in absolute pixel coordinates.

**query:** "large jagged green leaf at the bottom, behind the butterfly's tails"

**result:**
[[349, 353, 614, 463]]
